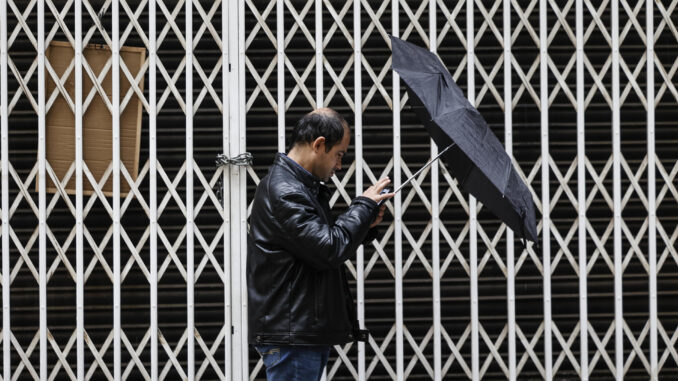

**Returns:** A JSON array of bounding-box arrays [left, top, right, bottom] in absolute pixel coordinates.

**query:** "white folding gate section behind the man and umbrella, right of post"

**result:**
[[245, 0, 678, 380]]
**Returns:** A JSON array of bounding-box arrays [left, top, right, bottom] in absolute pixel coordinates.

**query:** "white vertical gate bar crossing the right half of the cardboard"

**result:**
[[111, 0, 121, 381]]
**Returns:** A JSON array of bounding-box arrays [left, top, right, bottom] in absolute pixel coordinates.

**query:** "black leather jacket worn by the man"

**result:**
[[247, 153, 377, 345]]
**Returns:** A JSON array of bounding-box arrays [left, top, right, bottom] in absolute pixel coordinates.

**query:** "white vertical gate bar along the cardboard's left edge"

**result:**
[[37, 0, 49, 380]]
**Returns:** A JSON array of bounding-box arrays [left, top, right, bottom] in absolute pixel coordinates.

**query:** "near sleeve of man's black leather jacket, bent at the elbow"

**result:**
[[273, 192, 377, 270]]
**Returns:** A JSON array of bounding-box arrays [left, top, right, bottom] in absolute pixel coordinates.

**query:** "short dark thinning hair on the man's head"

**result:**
[[289, 108, 348, 152]]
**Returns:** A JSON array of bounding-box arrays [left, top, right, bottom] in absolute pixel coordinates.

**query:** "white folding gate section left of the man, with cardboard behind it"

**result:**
[[0, 0, 247, 381]]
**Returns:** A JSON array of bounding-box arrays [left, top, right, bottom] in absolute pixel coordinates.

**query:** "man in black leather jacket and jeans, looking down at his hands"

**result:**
[[247, 108, 393, 380]]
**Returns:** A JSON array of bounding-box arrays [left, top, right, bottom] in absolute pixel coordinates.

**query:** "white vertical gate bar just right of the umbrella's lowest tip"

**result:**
[[539, 0, 553, 380]]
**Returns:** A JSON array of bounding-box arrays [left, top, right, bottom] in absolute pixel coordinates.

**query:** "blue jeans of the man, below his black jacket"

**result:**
[[254, 345, 330, 381]]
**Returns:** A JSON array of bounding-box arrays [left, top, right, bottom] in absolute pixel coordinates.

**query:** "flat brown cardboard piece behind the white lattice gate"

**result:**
[[42, 41, 146, 197]]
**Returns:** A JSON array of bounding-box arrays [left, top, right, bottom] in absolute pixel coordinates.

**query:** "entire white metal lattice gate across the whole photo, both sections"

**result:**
[[0, 0, 678, 380]]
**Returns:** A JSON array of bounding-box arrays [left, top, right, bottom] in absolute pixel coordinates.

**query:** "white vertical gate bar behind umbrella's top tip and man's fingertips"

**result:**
[[391, 1, 404, 381]]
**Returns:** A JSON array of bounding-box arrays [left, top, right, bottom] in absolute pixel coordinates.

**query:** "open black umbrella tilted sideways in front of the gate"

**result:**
[[391, 36, 537, 242]]
